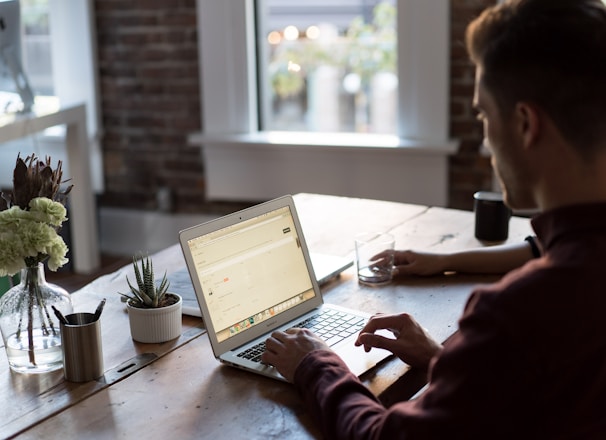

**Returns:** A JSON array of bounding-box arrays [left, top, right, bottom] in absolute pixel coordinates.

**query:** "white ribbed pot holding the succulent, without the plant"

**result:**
[[126, 293, 183, 343]]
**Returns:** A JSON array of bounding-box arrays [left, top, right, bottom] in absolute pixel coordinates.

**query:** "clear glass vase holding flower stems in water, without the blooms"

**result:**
[[0, 263, 73, 373]]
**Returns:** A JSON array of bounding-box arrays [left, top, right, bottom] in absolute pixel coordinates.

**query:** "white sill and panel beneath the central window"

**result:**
[[189, 132, 459, 206]]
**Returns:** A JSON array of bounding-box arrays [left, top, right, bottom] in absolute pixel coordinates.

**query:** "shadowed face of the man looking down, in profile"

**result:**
[[474, 67, 536, 209]]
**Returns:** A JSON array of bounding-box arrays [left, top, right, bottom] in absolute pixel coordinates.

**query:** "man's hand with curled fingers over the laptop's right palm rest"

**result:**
[[356, 313, 442, 369]]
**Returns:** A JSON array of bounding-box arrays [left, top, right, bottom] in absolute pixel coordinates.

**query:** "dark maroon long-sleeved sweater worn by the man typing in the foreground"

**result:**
[[295, 203, 606, 440]]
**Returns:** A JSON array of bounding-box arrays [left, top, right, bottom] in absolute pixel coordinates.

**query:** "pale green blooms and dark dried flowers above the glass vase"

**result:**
[[0, 154, 73, 276]]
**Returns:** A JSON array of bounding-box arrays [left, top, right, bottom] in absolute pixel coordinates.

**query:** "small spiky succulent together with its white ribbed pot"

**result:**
[[118, 257, 183, 343]]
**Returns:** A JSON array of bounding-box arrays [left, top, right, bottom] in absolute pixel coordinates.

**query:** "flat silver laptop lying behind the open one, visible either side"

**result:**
[[169, 252, 353, 317]]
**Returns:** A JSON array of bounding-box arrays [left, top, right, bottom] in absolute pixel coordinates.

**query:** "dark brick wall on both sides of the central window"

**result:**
[[95, 0, 494, 213]]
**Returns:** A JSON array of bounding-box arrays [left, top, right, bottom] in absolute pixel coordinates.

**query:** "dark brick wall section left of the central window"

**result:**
[[95, 0, 204, 211]]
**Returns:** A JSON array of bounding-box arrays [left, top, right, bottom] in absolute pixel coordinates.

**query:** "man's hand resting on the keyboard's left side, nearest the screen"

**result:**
[[261, 328, 328, 382]]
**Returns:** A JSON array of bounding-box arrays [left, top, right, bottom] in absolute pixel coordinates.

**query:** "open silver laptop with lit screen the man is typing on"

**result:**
[[179, 195, 391, 380]]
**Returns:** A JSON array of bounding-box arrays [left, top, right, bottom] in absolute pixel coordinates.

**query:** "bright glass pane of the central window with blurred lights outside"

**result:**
[[256, 0, 398, 134]]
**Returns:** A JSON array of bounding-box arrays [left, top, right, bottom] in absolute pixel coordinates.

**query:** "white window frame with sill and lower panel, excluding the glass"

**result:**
[[194, 0, 458, 206]]
